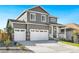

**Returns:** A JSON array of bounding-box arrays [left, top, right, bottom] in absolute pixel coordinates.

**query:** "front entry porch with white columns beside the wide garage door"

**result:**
[[49, 24, 64, 40]]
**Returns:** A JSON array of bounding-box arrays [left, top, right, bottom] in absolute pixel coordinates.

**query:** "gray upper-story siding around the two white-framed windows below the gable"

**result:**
[[27, 12, 49, 24]]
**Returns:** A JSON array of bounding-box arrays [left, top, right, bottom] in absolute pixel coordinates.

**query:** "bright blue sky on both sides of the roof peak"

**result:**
[[0, 5, 79, 29]]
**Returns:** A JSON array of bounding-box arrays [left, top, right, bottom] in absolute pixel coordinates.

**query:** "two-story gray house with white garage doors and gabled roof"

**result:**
[[7, 6, 63, 41]]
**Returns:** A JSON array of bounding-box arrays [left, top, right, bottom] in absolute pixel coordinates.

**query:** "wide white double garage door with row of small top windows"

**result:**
[[30, 29, 48, 40]]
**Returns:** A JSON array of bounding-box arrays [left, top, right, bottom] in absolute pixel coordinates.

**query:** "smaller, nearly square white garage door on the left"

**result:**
[[14, 29, 26, 41]]
